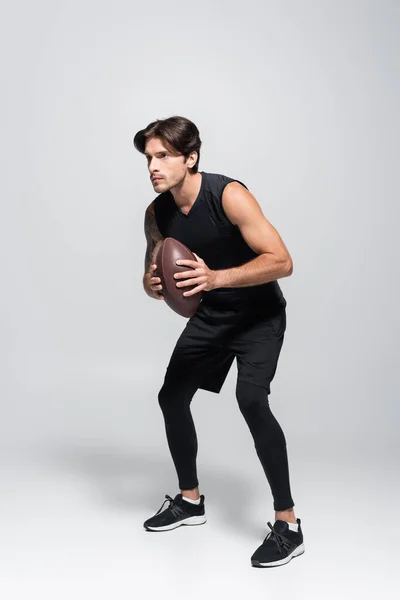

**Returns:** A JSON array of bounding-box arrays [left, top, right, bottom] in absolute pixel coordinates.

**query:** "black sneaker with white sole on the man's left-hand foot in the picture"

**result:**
[[143, 494, 207, 531]]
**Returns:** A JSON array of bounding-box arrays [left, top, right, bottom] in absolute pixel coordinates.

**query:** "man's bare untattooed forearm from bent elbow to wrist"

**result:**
[[215, 253, 293, 288]]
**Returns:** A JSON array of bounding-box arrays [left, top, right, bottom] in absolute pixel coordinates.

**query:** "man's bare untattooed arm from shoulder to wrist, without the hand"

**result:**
[[214, 181, 293, 288]]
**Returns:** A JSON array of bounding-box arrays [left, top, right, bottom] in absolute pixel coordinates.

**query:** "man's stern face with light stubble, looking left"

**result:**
[[145, 138, 193, 193]]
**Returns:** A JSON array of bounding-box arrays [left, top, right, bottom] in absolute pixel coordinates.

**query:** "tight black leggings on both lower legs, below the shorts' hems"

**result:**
[[158, 379, 294, 511]]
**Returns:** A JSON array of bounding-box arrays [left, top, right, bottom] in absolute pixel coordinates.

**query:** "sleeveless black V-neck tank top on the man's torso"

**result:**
[[154, 171, 286, 312]]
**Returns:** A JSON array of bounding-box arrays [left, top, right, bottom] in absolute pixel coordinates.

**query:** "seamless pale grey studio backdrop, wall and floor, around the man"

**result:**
[[0, 0, 400, 598]]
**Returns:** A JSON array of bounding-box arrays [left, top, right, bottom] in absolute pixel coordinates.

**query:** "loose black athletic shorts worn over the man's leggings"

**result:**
[[165, 302, 286, 394]]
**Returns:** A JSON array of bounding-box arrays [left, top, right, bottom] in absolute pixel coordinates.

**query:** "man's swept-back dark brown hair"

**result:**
[[133, 116, 201, 173]]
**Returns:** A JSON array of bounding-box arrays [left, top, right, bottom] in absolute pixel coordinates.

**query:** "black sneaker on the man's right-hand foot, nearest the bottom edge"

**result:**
[[251, 519, 304, 567]]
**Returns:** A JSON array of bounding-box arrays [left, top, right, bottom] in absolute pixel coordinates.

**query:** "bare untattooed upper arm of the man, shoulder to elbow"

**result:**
[[222, 182, 289, 257]]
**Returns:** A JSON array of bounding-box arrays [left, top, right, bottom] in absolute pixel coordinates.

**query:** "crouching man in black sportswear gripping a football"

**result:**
[[134, 116, 304, 567]]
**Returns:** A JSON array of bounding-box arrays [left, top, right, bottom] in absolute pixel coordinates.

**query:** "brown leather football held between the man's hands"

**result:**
[[154, 237, 202, 318]]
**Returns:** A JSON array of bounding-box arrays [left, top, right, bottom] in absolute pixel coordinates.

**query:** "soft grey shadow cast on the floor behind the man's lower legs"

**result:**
[[45, 446, 264, 537]]
